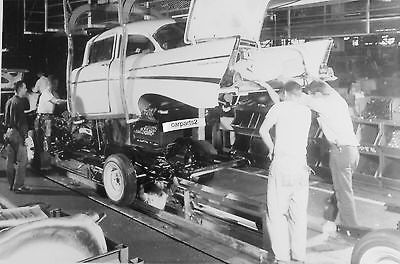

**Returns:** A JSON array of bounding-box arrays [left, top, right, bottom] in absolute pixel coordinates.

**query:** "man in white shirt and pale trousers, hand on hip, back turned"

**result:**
[[260, 80, 311, 263]]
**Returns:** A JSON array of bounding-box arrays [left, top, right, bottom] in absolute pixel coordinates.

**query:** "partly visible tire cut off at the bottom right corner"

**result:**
[[351, 229, 400, 264]]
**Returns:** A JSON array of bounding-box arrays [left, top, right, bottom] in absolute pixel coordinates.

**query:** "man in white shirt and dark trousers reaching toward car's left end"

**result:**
[[33, 76, 66, 169]]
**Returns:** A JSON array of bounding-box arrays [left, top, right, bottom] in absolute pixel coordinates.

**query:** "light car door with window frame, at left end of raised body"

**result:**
[[75, 34, 116, 115]]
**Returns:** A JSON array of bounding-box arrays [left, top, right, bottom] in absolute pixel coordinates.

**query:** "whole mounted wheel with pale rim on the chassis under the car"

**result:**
[[103, 154, 137, 205]]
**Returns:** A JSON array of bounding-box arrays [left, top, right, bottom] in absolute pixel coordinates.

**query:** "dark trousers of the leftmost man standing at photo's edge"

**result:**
[[5, 128, 28, 190]]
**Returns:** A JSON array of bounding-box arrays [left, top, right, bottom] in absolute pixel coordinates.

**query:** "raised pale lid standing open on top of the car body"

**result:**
[[185, 0, 296, 44]]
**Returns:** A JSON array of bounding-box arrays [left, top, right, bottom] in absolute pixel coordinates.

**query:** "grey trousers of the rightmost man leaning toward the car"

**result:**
[[329, 145, 360, 227]]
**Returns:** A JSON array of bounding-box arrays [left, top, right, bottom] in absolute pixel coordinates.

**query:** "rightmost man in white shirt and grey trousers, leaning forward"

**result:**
[[303, 78, 360, 228]]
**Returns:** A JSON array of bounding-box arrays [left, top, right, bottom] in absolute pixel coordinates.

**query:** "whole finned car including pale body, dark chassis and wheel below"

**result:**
[[50, 0, 332, 208]]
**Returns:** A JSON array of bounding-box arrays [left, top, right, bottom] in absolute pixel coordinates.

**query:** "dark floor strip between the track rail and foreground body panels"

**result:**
[[0, 169, 227, 263]]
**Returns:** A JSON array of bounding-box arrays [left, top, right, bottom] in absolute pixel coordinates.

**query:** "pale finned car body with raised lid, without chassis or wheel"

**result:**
[[71, 0, 332, 118]]
